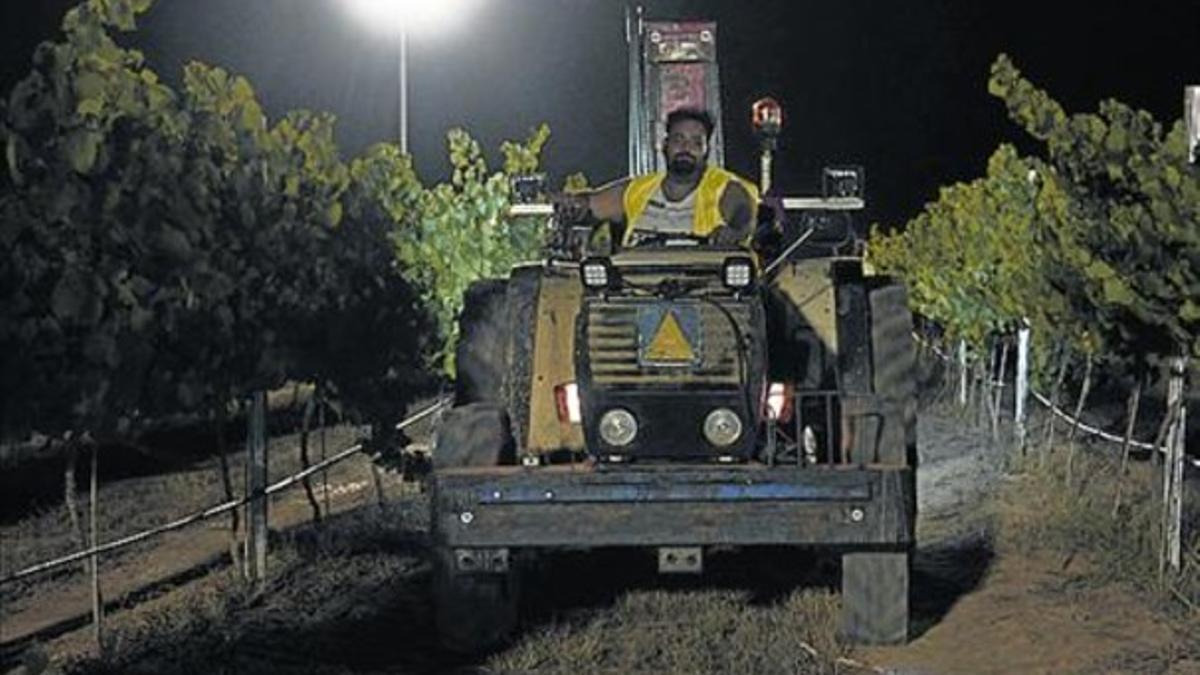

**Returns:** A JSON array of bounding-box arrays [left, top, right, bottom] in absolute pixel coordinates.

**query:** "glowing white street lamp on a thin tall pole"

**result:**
[[346, 0, 478, 155]]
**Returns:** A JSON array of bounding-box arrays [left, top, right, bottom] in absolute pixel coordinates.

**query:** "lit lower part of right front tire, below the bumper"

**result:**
[[841, 550, 912, 645]]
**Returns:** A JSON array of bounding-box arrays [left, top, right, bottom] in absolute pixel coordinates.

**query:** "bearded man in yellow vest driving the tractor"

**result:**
[[554, 108, 758, 246]]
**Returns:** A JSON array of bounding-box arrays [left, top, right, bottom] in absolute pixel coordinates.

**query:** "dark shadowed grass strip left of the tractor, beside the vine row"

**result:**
[[55, 501, 431, 675]]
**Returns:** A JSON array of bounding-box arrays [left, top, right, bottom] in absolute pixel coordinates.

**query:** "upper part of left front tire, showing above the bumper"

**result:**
[[433, 404, 516, 470]]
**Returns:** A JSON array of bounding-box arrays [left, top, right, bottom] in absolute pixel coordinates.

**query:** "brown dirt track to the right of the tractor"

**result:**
[[859, 411, 1200, 674]]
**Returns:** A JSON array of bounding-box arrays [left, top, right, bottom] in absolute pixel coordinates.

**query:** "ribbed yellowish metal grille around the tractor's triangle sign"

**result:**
[[586, 300, 751, 387]]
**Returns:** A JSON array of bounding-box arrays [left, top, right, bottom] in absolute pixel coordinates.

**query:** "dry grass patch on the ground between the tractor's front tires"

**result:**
[[488, 590, 847, 673]]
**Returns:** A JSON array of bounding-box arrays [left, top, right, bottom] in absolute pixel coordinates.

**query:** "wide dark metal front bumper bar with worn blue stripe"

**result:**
[[432, 465, 916, 548]]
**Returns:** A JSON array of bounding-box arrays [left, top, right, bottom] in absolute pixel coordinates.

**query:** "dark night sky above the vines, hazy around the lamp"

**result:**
[[0, 0, 1200, 223]]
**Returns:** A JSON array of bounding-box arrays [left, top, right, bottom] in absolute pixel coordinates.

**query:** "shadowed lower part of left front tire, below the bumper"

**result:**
[[433, 546, 521, 653]]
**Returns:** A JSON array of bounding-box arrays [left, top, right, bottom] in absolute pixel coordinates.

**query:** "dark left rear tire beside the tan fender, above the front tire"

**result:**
[[455, 279, 509, 406]]
